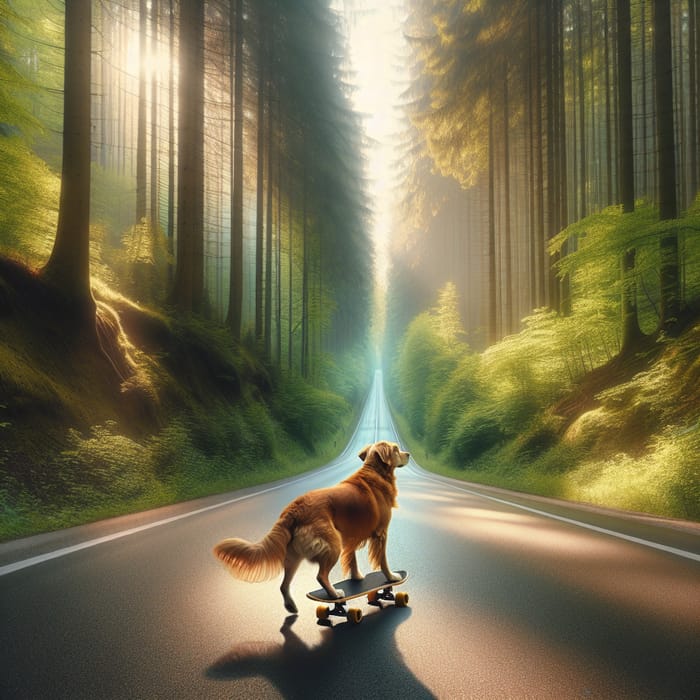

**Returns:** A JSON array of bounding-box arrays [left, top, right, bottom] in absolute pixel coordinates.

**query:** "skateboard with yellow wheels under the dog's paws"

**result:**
[[306, 571, 408, 625]]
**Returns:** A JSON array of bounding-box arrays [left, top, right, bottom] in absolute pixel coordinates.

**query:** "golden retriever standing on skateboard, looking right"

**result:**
[[214, 441, 410, 613]]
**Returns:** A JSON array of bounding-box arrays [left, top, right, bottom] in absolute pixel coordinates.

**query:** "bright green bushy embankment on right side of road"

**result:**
[[391, 288, 700, 521]]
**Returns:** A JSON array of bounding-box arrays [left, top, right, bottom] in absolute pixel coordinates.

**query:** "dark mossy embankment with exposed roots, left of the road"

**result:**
[[0, 257, 367, 540]]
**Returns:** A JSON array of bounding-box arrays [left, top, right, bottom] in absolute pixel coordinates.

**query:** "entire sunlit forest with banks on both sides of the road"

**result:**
[[0, 0, 700, 538]]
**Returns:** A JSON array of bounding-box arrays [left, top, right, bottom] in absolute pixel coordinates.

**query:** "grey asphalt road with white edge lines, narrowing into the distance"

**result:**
[[0, 376, 700, 700]]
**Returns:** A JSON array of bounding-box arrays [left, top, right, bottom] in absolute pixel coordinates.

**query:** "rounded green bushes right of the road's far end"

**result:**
[[394, 297, 590, 465]]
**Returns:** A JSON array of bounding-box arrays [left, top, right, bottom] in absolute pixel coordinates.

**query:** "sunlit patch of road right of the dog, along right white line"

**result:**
[[396, 473, 700, 664]]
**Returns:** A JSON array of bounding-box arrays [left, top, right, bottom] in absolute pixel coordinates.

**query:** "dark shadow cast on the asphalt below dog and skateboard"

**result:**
[[206, 606, 435, 699]]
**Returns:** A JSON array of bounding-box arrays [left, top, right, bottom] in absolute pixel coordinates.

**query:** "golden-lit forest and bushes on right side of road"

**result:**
[[387, 0, 700, 519]]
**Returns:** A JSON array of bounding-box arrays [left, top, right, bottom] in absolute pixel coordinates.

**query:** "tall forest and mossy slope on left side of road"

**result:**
[[0, 0, 372, 537]]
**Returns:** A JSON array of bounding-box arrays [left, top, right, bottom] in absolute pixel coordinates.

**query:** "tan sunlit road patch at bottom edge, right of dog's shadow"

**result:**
[[397, 591, 650, 700]]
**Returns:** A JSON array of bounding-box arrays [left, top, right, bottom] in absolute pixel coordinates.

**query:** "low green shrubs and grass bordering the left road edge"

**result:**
[[0, 388, 357, 540]]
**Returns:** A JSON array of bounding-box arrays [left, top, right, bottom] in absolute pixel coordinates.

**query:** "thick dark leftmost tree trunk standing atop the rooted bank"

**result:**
[[41, 0, 95, 319]]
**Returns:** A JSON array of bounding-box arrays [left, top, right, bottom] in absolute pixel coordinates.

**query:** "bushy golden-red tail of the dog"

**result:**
[[214, 513, 292, 582]]
